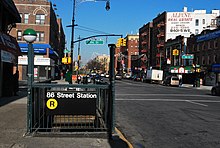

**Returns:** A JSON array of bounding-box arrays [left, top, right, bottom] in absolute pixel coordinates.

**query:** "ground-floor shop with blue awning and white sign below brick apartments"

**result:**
[[18, 43, 58, 81]]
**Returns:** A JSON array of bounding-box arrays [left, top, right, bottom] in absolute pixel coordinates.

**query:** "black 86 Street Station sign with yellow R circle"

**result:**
[[45, 91, 98, 115]]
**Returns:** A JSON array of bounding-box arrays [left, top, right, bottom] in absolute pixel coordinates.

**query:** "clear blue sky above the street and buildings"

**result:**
[[51, 0, 220, 64]]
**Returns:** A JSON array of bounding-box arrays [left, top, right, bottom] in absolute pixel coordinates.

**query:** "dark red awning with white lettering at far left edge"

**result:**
[[0, 32, 22, 56]]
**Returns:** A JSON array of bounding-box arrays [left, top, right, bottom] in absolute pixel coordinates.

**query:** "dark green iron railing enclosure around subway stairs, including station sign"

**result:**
[[28, 83, 112, 134]]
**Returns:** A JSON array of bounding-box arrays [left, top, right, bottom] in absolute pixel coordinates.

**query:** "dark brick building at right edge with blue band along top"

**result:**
[[187, 29, 220, 85]]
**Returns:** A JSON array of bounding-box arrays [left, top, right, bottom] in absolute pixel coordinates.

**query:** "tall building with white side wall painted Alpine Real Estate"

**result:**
[[144, 7, 220, 69]]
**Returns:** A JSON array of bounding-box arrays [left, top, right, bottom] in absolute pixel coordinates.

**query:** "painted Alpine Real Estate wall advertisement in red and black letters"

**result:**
[[166, 12, 195, 40]]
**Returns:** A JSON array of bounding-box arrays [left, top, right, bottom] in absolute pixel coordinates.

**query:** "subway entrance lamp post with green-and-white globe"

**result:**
[[23, 29, 37, 132]]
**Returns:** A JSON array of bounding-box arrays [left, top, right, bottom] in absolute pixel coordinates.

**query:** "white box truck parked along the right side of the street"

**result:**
[[144, 69, 163, 83]]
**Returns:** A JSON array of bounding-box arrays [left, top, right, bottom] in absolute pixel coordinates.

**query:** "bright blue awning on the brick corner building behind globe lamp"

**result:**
[[19, 43, 56, 54]]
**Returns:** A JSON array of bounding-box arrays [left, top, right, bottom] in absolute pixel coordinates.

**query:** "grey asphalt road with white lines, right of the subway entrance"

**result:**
[[115, 80, 220, 148]]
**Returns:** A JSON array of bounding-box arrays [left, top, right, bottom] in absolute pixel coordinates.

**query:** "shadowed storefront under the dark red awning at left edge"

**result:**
[[0, 32, 21, 97]]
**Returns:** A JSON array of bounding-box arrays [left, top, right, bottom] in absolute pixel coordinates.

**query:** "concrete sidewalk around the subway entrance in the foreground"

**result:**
[[0, 80, 129, 148]]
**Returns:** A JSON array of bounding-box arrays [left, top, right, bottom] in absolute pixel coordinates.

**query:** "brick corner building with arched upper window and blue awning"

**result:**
[[11, 0, 65, 80]]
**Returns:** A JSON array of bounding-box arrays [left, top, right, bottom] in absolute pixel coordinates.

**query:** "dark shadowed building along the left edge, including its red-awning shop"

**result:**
[[0, 0, 21, 97]]
